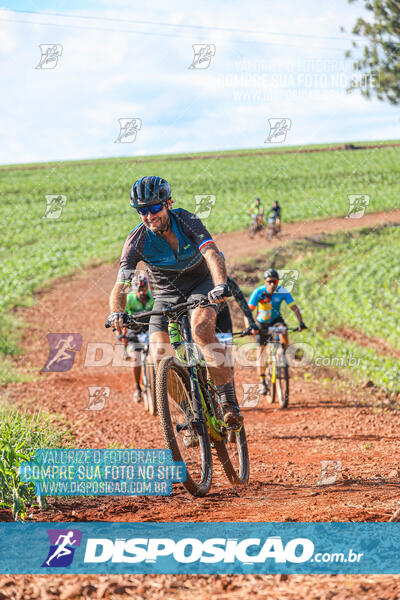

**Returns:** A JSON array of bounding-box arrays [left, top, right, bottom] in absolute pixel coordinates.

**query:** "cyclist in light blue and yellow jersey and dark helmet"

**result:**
[[244, 269, 307, 395]]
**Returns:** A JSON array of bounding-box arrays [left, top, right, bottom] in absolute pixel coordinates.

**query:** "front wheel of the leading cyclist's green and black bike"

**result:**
[[156, 356, 212, 496]]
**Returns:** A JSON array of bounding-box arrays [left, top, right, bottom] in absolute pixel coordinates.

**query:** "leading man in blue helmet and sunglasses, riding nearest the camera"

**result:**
[[109, 175, 243, 428]]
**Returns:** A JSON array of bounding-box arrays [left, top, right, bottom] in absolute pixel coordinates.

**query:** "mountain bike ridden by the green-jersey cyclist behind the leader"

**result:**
[[105, 313, 157, 415]]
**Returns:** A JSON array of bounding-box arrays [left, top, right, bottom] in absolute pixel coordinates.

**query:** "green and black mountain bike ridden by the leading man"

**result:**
[[128, 300, 250, 496]]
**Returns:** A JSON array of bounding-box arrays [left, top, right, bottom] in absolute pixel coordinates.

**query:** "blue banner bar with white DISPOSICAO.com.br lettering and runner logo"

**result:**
[[0, 523, 400, 574]]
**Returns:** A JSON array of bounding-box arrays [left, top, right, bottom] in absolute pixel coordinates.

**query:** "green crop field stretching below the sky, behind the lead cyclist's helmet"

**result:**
[[0, 142, 400, 380]]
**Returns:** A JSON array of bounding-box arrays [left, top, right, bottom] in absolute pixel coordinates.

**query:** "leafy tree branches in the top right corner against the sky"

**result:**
[[342, 0, 400, 104]]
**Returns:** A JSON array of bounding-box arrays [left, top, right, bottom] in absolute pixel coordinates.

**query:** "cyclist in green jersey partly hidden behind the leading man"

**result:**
[[120, 273, 154, 402]]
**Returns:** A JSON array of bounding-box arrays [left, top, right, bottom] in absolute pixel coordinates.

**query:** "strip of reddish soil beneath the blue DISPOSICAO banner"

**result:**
[[0, 575, 400, 600]]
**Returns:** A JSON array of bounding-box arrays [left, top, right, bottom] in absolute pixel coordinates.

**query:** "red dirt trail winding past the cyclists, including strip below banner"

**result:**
[[0, 211, 400, 599]]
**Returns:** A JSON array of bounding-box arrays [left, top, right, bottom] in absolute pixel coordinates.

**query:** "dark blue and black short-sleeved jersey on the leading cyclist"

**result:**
[[117, 208, 213, 296]]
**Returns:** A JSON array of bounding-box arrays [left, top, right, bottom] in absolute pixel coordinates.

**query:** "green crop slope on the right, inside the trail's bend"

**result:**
[[234, 226, 400, 393]]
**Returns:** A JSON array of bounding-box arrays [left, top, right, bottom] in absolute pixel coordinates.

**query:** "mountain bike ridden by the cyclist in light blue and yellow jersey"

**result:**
[[265, 325, 300, 408]]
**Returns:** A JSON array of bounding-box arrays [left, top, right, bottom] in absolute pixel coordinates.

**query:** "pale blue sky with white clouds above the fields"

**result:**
[[0, 0, 400, 164]]
